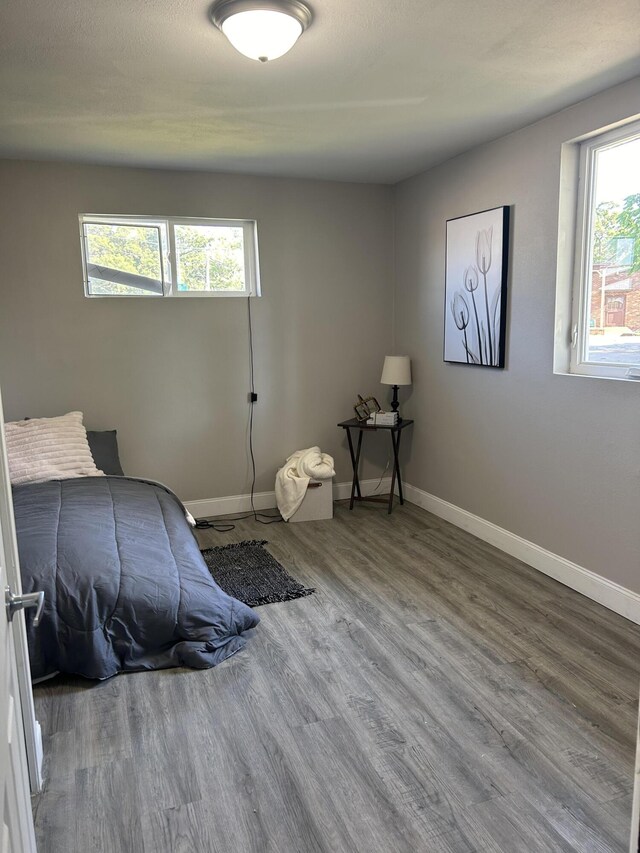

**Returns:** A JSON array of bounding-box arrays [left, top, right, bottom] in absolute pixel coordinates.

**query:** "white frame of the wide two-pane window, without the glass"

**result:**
[[78, 213, 260, 299]]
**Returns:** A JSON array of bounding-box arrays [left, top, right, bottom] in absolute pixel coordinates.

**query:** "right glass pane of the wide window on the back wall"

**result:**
[[175, 225, 246, 293]]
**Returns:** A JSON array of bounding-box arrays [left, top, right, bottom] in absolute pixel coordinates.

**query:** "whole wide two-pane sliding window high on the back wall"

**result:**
[[80, 214, 260, 297]]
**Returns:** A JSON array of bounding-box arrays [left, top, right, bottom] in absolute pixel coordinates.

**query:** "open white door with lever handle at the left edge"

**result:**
[[0, 390, 36, 853]]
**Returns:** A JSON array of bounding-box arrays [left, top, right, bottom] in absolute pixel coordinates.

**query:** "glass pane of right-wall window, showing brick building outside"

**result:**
[[586, 137, 640, 365]]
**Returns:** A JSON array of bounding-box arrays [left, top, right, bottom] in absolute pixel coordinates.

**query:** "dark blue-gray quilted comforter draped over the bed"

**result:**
[[13, 477, 259, 679]]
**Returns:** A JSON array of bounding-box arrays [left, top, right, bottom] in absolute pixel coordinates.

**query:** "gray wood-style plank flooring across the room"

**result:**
[[34, 504, 640, 853]]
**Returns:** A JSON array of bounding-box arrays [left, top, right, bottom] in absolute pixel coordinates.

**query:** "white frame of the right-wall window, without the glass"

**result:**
[[569, 121, 640, 379]]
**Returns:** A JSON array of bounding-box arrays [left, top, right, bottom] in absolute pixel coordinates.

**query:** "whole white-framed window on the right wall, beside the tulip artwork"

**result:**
[[570, 122, 640, 378]]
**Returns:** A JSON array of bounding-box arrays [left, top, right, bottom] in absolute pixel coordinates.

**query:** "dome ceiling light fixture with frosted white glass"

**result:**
[[210, 0, 312, 62]]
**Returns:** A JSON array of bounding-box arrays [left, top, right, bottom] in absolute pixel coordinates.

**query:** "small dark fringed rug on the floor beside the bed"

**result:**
[[202, 539, 315, 607]]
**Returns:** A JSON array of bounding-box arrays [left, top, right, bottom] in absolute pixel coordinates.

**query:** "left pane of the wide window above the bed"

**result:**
[[84, 223, 162, 296]]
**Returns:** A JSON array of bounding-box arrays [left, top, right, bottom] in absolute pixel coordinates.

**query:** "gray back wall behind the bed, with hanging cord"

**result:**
[[0, 161, 392, 500]]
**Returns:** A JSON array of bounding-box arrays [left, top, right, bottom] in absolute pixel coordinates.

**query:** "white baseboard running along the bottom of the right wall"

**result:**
[[403, 484, 640, 625]]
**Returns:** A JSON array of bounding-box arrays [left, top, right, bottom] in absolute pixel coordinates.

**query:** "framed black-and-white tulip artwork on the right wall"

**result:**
[[444, 207, 509, 367]]
